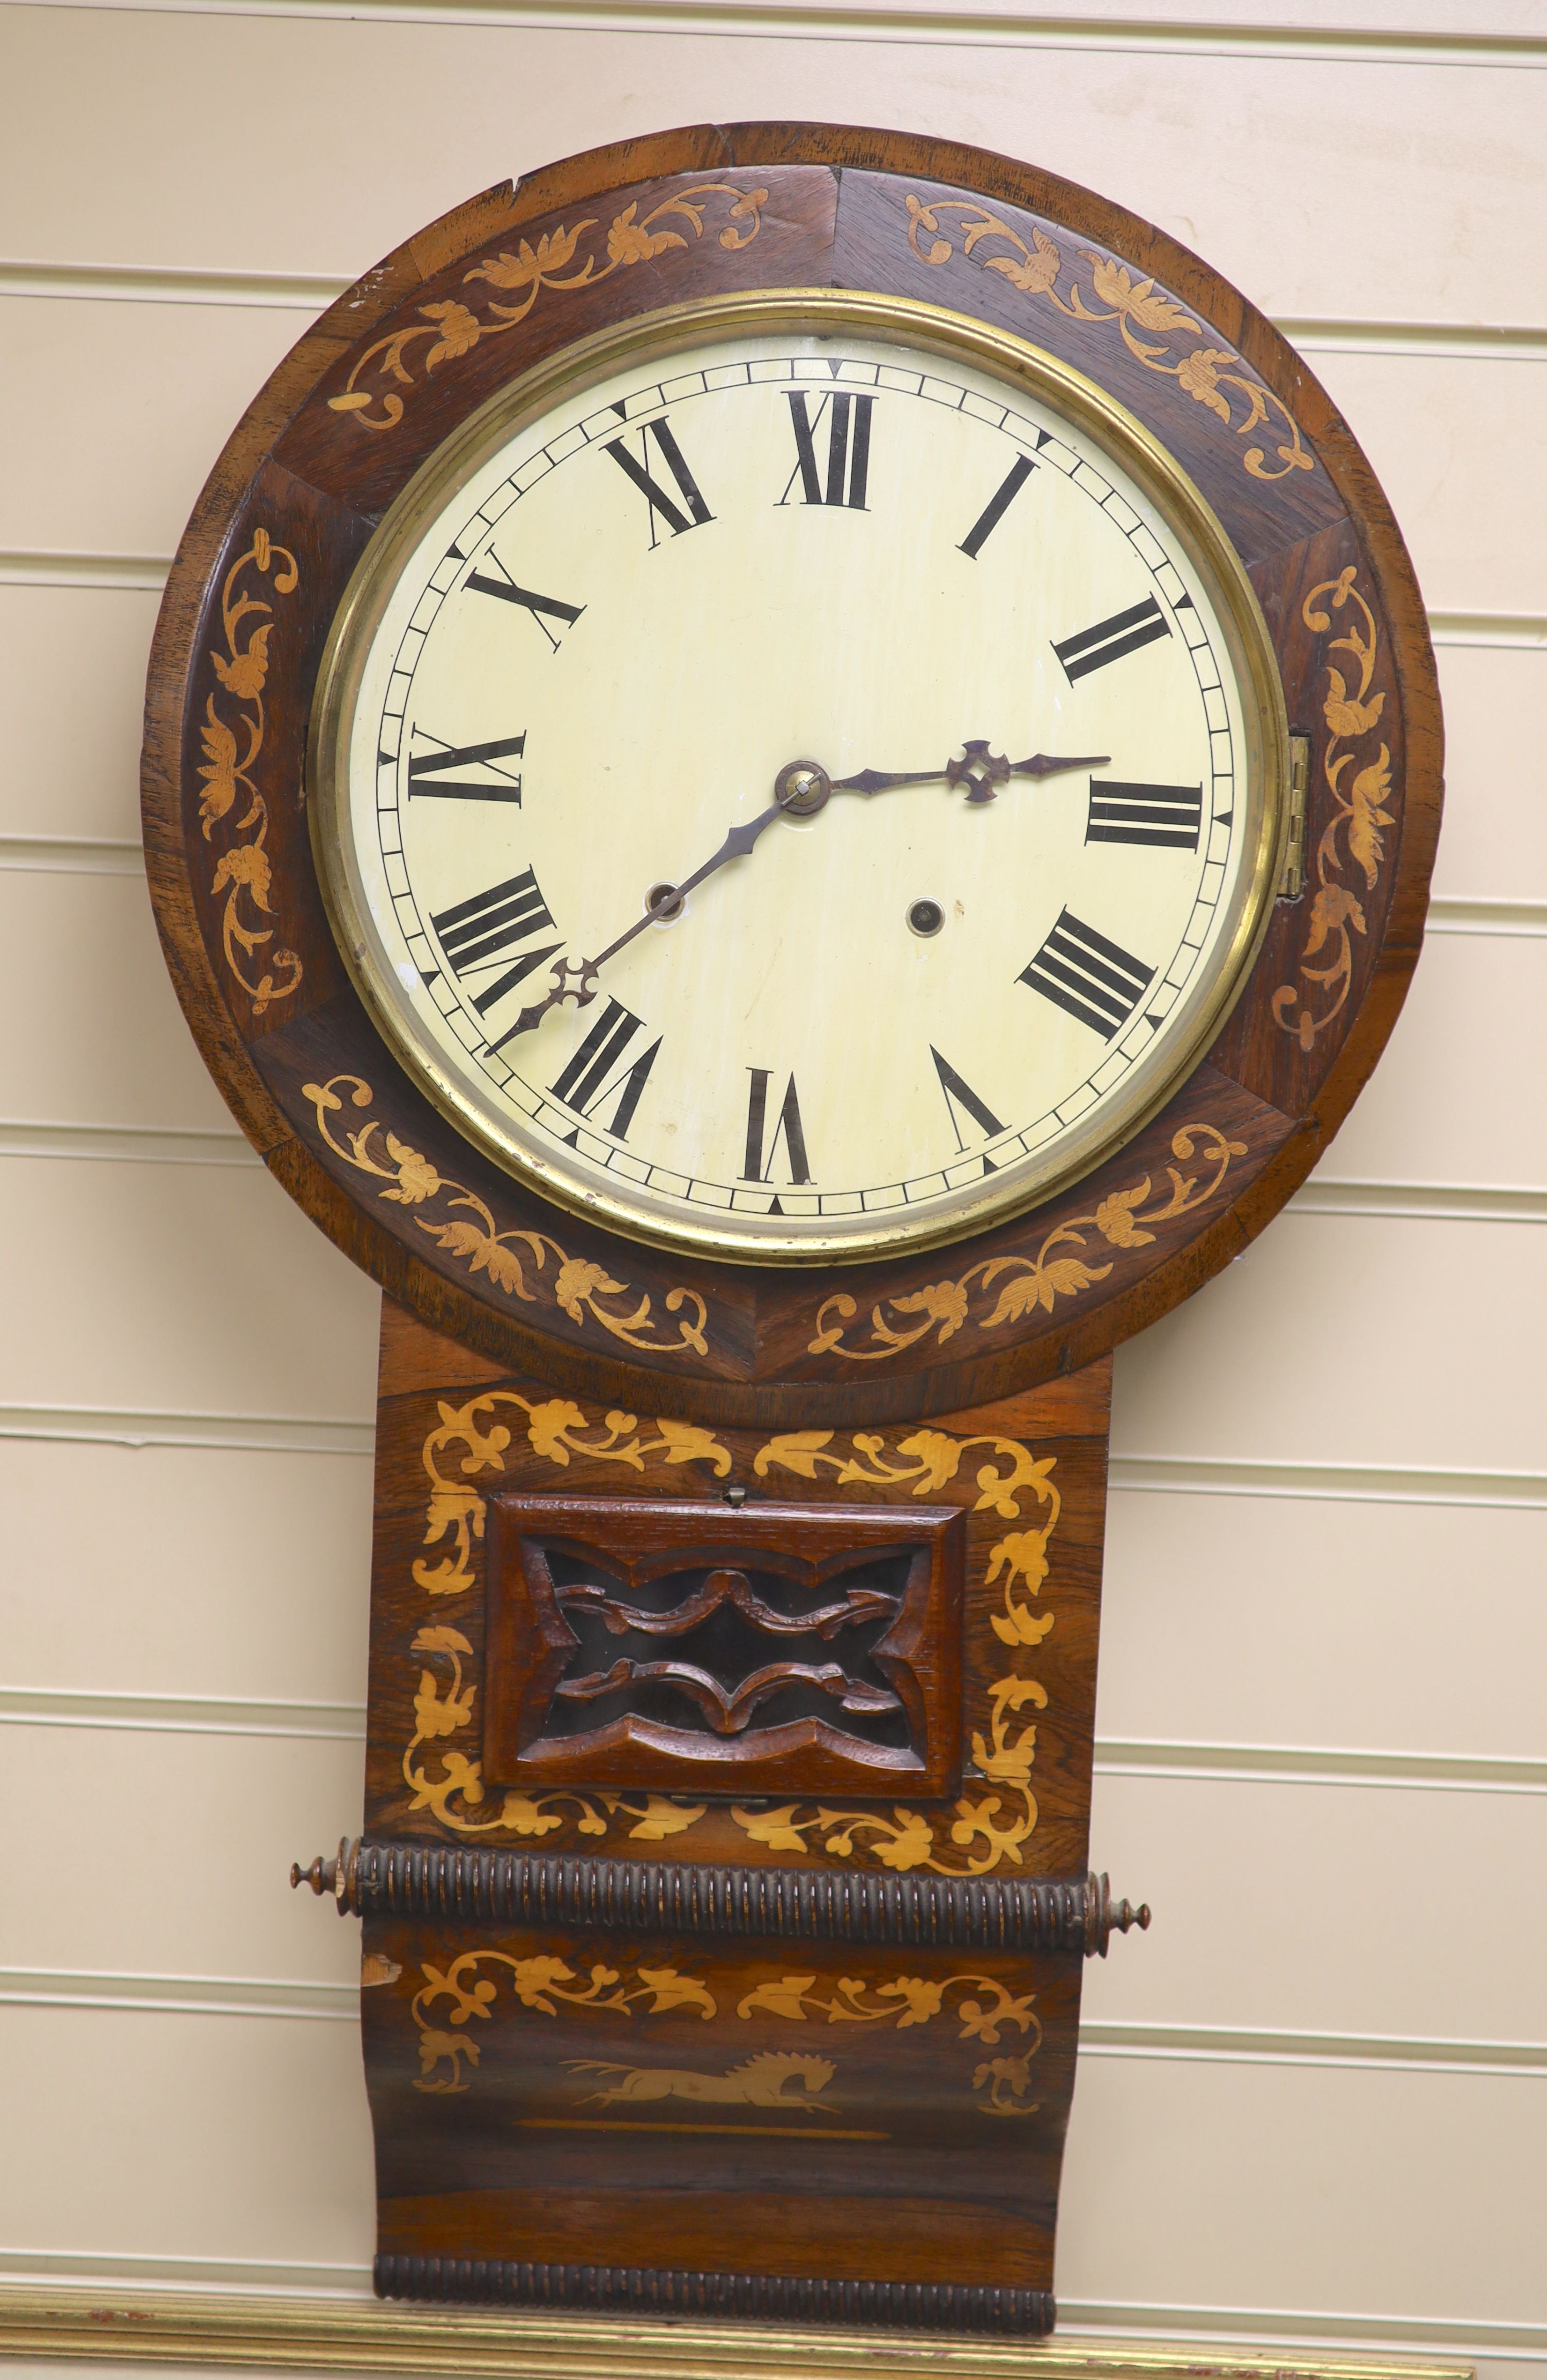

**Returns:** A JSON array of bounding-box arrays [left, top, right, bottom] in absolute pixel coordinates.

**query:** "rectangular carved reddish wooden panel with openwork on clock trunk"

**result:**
[[483, 1495, 966, 1795]]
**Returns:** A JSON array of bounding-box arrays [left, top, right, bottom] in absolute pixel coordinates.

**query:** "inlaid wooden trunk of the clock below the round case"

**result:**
[[348, 1302, 1111, 2333]]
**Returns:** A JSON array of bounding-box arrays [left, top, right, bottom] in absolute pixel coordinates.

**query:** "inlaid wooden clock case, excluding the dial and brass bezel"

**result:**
[[143, 126, 1442, 2333]]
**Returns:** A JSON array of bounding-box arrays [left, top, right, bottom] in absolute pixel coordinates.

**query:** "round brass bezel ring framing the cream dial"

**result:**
[[307, 288, 1290, 1266]]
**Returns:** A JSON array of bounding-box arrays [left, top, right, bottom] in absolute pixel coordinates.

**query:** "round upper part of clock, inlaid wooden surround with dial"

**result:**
[[143, 126, 1440, 1426]]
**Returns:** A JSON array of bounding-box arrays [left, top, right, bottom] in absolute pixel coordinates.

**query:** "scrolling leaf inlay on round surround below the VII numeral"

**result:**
[[302, 1073, 709, 1361]]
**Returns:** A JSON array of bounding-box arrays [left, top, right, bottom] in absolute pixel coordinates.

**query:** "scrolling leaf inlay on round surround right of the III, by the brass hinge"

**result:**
[[1273, 564, 1397, 1050]]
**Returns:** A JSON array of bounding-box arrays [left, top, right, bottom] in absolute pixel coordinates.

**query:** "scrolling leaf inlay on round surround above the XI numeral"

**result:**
[[328, 181, 769, 431]]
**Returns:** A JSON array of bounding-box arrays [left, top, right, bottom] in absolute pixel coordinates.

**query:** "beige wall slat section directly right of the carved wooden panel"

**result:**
[[1095, 1494, 1547, 1761]]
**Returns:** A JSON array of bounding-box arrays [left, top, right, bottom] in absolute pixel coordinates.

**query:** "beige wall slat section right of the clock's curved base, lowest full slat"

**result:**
[[1052, 2056, 1547, 2313]]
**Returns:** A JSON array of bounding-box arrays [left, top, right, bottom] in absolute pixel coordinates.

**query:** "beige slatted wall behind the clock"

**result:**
[[0, 0, 1547, 2380]]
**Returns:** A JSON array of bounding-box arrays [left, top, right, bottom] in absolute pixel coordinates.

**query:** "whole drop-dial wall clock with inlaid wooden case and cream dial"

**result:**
[[145, 126, 1440, 2333]]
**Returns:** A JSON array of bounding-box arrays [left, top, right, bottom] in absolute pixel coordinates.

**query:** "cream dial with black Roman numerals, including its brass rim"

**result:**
[[312, 298, 1285, 1264]]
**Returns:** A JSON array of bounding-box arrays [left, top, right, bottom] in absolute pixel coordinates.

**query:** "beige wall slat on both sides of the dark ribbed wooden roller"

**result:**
[[0, 1723, 1547, 2047]]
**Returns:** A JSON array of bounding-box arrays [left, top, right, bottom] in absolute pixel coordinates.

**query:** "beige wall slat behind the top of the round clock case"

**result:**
[[5, 0, 1542, 331]]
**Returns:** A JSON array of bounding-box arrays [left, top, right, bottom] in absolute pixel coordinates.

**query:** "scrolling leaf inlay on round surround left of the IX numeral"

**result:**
[[200, 528, 305, 1016]]
